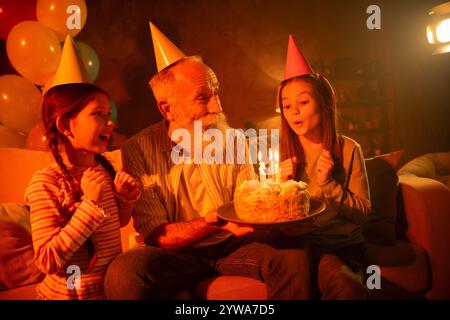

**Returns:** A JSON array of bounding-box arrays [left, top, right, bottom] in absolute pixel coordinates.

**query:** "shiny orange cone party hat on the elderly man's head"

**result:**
[[149, 21, 186, 72]]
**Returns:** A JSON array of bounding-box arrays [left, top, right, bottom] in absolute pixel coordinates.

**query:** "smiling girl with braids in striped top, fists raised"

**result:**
[[25, 83, 140, 299]]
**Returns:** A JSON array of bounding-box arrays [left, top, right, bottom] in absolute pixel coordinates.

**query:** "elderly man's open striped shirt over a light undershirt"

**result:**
[[122, 121, 256, 244]]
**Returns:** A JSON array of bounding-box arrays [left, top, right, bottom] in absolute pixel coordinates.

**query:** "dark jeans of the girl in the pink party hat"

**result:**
[[308, 244, 368, 300]]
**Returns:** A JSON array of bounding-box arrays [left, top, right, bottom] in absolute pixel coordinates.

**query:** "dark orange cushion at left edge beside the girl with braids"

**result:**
[[0, 203, 44, 290]]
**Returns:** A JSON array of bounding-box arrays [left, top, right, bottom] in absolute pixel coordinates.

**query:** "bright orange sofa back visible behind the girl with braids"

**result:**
[[0, 148, 134, 250]]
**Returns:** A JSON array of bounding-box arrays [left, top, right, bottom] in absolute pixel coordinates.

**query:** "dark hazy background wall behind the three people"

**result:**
[[32, 0, 450, 162]]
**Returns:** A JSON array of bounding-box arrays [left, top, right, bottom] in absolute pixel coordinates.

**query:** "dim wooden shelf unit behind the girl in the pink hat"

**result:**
[[315, 57, 392, 157]]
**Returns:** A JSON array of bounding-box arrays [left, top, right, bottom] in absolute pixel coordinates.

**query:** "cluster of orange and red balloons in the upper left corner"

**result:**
[[0, 0, 111, 150]]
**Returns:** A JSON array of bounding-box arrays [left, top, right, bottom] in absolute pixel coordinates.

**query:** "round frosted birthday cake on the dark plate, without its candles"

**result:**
[[234, 180, 310, 223]]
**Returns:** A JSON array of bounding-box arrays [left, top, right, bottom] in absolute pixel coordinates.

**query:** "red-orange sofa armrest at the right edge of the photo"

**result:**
[[399, 175, 450, 299]]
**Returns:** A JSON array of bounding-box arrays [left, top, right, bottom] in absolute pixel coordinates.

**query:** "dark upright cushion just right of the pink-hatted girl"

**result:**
[[363, 150, 404, 244]]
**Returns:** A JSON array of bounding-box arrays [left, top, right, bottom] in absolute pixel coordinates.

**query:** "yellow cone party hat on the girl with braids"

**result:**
[[45, 35, 92, 91]]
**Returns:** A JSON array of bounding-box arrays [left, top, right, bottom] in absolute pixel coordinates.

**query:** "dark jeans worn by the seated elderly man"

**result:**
[[105, 231, 311, 300]]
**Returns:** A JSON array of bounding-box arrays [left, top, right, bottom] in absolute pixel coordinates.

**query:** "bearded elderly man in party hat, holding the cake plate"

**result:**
[[105, 25, 310, 299]]
